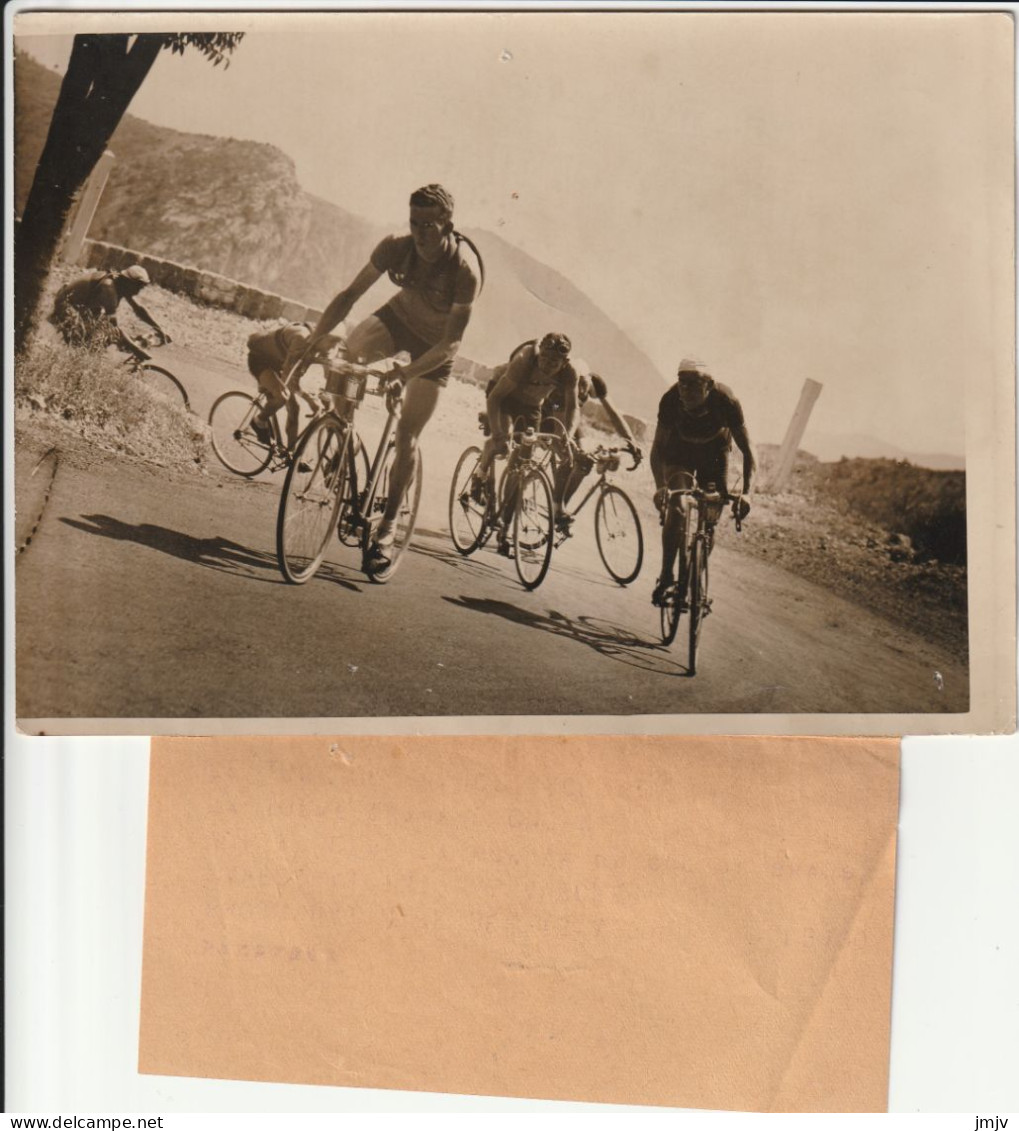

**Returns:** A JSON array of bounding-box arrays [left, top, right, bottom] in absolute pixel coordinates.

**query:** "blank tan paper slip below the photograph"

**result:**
[[140, 736, 899, 1112]]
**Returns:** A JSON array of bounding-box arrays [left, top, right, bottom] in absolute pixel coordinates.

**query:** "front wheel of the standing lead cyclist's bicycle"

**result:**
[[276, 416, 351, 585]]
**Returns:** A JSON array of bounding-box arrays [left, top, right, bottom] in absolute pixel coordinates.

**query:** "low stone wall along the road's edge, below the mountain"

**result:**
[[81, 240, 322, 325]]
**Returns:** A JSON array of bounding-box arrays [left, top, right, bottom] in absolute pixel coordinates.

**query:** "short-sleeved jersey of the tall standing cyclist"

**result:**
[[371, 233, 480, 346]]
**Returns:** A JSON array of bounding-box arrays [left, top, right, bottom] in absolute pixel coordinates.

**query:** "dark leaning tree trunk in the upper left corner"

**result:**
[[15, 35, 166, 352]]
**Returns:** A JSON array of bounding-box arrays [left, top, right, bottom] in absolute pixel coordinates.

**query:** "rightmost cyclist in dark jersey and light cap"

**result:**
[[650, 357, 754, 605]]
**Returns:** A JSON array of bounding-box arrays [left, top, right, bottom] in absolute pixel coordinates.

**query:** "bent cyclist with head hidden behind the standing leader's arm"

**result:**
[[248, 322, 340, 451]]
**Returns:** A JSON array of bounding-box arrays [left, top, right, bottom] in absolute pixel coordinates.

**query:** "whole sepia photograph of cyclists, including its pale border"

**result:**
[[8, 9, 1016, 734]]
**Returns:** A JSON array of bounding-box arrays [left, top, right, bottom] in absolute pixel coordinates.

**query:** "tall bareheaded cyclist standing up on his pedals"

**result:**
[[308, 184, 483, 570]]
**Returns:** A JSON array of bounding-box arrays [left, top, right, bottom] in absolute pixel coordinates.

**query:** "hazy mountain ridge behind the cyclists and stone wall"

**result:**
[[14, 52, 666, 420]]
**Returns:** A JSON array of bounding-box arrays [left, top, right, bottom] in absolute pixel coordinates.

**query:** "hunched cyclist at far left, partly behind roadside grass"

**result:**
[[50, 265, 170, 359]]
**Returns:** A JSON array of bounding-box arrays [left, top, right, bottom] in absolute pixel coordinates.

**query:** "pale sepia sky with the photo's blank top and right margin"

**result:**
[[16, 11, 1014, 455]]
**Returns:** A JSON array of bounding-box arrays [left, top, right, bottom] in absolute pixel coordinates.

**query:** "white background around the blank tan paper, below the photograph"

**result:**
[[6, 735, 1019, 1108]]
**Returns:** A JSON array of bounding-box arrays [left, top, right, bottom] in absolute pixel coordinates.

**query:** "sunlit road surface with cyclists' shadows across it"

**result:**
[[17, 348, 968, 718]]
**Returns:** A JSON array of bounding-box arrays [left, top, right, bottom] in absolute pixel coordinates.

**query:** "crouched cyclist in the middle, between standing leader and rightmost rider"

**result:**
[[470, 331, 579, 554]]
